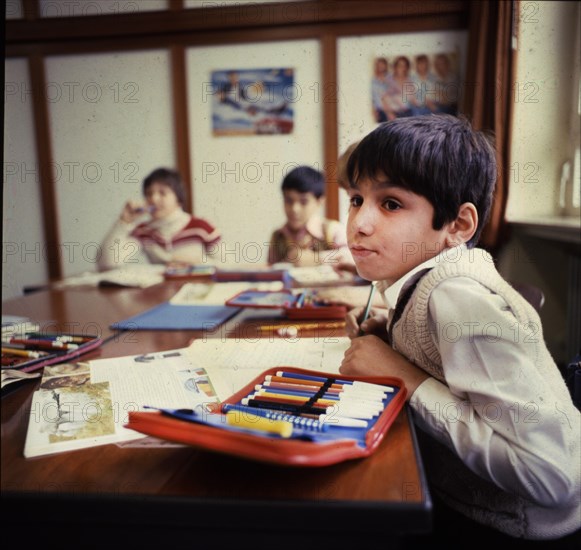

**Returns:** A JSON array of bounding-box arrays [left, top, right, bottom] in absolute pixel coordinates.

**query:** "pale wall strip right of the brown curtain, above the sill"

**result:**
[[506, 2, 579, 221]]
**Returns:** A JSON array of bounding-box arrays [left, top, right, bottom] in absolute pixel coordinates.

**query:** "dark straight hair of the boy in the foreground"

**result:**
[[347, 115, 496, 247]]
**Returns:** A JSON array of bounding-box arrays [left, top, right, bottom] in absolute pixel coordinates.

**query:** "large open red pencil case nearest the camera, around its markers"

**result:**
[[125, 367, 407, 467]]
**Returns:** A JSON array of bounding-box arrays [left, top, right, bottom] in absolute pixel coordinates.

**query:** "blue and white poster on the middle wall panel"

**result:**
[[211, 68, 296, 136]]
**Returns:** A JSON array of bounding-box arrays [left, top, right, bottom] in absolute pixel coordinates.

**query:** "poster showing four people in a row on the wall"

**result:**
[[371, 52, 460, 122]]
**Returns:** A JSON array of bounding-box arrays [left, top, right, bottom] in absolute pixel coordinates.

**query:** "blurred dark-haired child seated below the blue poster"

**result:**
[[268, 166, 352, 266]]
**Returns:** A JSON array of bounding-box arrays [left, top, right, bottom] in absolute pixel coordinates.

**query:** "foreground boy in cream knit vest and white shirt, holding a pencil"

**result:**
[[340, 115, 581, 547]]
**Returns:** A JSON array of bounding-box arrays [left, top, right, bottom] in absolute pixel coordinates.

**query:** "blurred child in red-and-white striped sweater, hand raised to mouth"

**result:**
[[99, 168, 220, 270]]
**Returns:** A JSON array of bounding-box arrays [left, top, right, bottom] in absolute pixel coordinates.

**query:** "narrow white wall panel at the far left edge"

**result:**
[[2, 58, 48, 300]]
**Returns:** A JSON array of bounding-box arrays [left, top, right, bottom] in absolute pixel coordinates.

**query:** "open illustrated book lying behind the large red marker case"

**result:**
[[24, 336, 349, 458]]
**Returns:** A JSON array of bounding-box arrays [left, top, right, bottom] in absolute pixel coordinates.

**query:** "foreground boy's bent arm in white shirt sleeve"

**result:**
[[410, 278, 581, 507]]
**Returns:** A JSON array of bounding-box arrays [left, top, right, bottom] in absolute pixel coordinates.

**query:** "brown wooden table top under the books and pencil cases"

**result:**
[[1, 281, 431, 540]]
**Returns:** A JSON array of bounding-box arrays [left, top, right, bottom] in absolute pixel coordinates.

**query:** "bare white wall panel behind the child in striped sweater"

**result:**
[[46, 50, 175, 276]]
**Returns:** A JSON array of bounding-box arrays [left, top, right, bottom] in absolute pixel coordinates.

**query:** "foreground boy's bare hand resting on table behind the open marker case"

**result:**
[[339, 336, 430, 401]]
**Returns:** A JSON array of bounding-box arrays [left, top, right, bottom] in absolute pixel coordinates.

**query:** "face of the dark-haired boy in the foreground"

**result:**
[[347, 180, 448, 284]]
